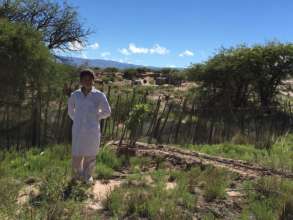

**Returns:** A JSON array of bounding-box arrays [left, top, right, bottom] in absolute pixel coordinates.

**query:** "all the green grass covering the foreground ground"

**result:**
[[0, 140, 293, 220]]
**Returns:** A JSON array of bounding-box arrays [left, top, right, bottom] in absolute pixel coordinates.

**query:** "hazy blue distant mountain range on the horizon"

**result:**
[[56, 56, 160, 69]]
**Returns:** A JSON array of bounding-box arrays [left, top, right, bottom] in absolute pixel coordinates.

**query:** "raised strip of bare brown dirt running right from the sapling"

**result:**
[[112, 142, 293, 179]]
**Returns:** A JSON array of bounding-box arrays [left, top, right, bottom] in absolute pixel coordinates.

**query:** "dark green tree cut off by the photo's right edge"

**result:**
[[250, 42, 293, 107]]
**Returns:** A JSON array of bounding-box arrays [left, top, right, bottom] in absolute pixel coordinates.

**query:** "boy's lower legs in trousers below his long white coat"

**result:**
[[72, 156, 96, 180]]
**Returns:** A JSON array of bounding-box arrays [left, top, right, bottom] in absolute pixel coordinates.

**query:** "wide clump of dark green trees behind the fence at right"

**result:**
[[187, 42, 293, 107]]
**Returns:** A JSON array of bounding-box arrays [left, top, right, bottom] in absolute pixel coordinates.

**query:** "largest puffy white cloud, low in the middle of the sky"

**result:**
[[119, 43, 170, 55]]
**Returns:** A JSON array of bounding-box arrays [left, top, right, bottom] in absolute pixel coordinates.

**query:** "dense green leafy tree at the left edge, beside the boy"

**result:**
[[0, 19, 74, 146]]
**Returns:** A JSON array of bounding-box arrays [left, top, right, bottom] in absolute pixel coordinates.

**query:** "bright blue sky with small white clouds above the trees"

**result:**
[[56, 0, 293, 67]]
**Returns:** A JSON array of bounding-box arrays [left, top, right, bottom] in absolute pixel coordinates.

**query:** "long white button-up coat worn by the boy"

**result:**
[[68, 86, 111, 156]]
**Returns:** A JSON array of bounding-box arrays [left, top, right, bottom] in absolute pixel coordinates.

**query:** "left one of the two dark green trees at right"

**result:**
[[190, 47, 253, 107]]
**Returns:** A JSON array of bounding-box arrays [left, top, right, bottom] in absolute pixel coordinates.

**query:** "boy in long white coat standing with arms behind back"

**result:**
[[68, 69, 111, 184]]
